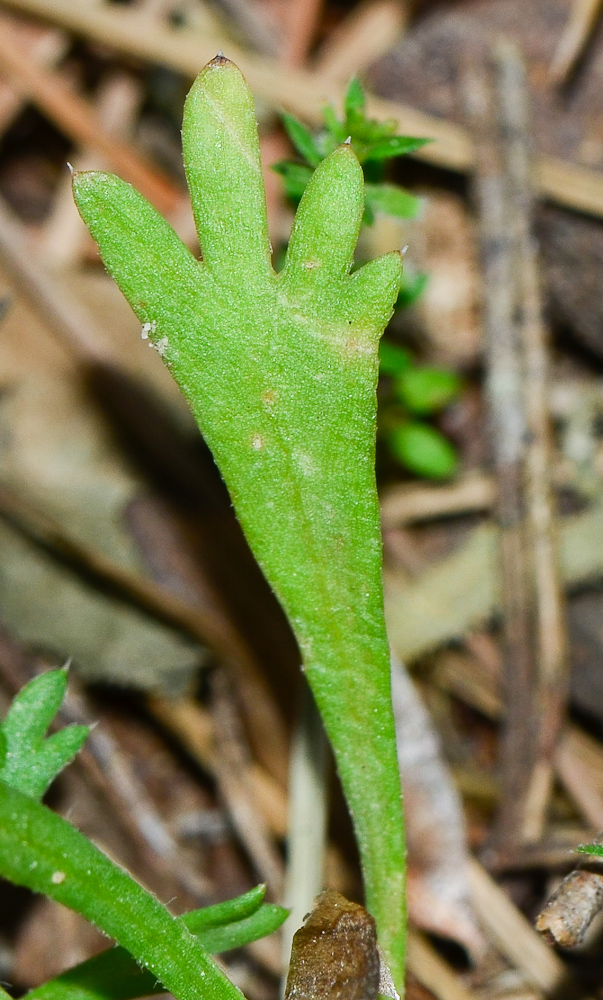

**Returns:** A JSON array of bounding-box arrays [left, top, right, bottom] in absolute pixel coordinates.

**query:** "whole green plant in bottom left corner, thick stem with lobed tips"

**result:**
[[0, 670, 287, 1000]]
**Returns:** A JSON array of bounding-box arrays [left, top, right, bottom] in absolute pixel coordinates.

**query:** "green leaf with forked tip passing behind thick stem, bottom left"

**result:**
[[25, 886, 289, 1000]]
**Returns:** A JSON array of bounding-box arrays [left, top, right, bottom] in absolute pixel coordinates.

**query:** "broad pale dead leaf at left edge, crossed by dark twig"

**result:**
[[0, 280, 204, 689]]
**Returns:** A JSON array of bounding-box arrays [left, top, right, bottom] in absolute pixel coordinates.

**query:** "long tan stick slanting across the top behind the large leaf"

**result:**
[[2, 0, 603, 216]]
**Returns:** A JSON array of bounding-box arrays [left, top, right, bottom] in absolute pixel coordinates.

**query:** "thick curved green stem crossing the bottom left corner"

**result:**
[[0, 782, 248, 1000]]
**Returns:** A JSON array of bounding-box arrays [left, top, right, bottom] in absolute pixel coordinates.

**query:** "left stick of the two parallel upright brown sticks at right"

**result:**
[[464, 54, 534, 845]]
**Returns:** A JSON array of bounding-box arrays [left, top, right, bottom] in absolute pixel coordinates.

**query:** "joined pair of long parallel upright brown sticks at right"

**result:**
[[467, 44, 567, 848]]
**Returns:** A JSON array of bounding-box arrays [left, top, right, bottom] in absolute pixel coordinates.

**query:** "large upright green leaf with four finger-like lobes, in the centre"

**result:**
[[74, 57, 405, 984]]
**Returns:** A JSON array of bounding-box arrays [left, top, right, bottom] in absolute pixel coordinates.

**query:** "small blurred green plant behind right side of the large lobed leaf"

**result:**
[[273, 79, 460, 479]]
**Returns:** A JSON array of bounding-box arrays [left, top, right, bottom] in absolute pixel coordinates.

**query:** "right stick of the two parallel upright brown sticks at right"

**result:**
[[497, 45, 569, 843]]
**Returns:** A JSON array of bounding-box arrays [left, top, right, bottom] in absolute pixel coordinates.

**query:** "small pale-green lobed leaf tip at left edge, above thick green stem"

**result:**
[[0, 670, 89, 799]]
